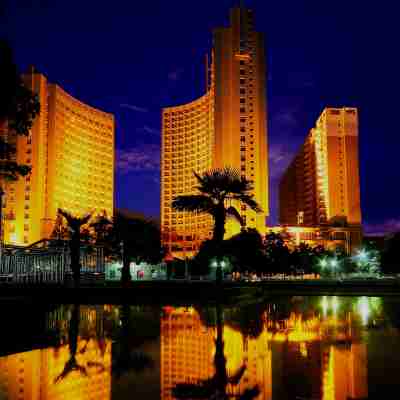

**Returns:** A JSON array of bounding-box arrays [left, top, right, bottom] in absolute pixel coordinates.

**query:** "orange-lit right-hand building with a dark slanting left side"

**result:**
[[279, 108, 361, 253]]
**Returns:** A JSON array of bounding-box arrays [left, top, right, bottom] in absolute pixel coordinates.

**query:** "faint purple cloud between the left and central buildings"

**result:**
[[116, 144, 160, 174]]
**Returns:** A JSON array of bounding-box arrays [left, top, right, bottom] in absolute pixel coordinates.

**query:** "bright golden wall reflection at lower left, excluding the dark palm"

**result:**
[[0, 338, 111, 400]]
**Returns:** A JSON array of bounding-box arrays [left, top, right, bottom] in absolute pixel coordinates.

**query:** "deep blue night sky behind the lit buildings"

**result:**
[[0, 0, 400, 232]]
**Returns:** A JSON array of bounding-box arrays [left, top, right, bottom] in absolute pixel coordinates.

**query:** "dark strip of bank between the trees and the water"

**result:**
[[0, 279, 400, 304]]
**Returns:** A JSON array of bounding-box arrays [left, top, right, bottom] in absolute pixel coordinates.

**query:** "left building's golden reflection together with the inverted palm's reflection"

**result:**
[[0, 306, 111, 400]]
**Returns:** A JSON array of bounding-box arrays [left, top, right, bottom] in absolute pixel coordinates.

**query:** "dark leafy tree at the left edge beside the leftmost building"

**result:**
[[0, 40, 40, 239]]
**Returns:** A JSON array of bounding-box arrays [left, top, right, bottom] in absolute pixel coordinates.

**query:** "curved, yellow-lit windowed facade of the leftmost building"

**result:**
[[47, 84, 114, 228]]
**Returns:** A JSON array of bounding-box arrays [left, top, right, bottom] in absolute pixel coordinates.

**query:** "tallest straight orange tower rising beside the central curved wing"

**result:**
[[213, 7, 269, 236]]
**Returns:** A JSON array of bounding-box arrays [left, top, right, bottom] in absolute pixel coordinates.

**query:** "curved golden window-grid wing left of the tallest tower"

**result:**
[[161, 90, 214, 256]]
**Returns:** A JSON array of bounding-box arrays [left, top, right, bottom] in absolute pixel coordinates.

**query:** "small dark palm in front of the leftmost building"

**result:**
[[58, 208, 91, 287]]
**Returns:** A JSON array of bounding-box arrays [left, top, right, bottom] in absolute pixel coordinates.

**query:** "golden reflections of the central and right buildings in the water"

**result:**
[[161, 297, 379, 400]]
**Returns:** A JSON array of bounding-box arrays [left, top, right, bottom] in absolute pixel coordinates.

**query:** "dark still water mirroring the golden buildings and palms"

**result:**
[[0, 297, 400, 400]]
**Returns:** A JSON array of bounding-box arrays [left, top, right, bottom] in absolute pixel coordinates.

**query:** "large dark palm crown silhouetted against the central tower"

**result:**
[[172, 167, 262, 245]]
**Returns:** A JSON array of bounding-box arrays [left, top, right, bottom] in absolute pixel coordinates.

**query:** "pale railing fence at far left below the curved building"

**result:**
[[0, 247, 105, 283]]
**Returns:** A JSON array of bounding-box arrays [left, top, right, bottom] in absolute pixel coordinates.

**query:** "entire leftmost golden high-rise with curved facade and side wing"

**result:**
[[3, 68, 114, 245]]
